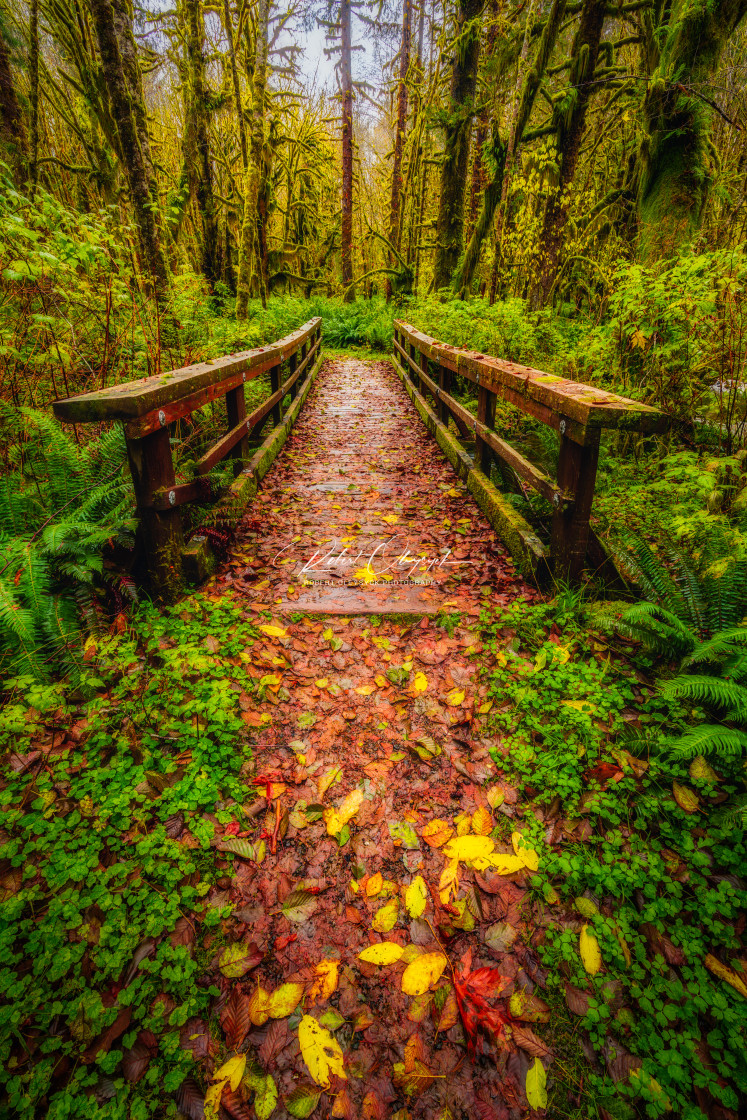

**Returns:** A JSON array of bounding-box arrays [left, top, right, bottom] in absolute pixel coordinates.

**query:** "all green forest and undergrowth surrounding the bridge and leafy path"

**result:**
[[0, 0, 747, 1120]]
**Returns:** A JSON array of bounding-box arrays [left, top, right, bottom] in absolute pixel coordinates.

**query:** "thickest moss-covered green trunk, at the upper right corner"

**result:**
[[638, 0, 747, 261]]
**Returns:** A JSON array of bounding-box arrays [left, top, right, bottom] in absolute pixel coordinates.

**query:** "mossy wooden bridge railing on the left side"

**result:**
[[53, 318, 321, 597]]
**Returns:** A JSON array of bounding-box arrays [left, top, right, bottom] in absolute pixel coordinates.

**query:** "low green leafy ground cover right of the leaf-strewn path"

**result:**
[[483, 599, 747, 1120]]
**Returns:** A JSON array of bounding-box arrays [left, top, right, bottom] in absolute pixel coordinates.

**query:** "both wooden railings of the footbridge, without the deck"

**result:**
[[54, 318, 666, 599]]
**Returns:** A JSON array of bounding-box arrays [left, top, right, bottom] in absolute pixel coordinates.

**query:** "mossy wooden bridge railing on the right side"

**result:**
[[394, 320, 667, 581]]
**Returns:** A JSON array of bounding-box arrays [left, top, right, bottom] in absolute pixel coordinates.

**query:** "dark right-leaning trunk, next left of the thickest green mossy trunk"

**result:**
[[531, 0, 606, 307]]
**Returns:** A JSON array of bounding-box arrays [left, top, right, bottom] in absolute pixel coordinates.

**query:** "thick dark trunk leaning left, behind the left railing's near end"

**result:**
[[88, 0, 169, 293]]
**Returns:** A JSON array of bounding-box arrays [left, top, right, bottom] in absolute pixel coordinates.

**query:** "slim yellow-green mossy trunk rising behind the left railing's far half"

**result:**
[[236, 0, 270, 319]]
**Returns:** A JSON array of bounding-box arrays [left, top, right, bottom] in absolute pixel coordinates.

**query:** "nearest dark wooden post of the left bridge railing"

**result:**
[[127, 426, 184, 601]]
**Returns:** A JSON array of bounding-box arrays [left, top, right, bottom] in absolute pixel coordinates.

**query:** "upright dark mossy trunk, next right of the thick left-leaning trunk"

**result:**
[[185, 0, 221, 286]]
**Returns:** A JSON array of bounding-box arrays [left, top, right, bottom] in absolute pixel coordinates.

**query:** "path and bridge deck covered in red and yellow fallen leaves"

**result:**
[[192, 361, 555, 1120]]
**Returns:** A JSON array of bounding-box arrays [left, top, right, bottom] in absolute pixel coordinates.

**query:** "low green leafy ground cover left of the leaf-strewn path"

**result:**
[[0, 596, 255, 1120]]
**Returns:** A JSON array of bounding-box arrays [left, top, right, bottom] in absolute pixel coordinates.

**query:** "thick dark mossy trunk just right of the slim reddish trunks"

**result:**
[[433, 0, 483, 290]]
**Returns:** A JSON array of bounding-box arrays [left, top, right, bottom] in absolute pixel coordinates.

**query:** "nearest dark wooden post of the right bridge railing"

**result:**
[[551, 419, 599, 584]]
